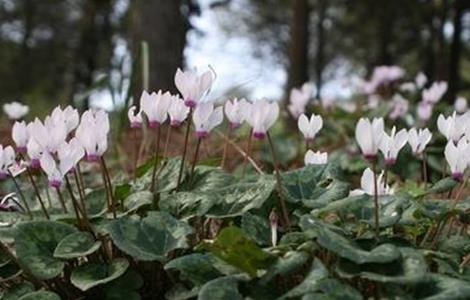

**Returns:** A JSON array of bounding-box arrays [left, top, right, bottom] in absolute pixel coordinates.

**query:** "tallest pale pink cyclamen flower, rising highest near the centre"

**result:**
[[175, 68, 213, 108]]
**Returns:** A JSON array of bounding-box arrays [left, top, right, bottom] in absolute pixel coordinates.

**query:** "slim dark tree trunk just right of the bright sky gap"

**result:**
[[286, 0, 310, 95]]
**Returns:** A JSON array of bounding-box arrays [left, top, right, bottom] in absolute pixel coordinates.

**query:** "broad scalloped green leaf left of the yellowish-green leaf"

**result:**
[[108, 211, 193, 262]]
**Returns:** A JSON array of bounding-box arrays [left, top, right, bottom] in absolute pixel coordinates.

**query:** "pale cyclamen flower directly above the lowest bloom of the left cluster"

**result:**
[[27, 118, 67, 154]]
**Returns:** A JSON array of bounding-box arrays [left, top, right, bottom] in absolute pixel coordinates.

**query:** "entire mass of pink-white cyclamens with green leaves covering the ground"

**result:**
[[0, 67, 470, 300]]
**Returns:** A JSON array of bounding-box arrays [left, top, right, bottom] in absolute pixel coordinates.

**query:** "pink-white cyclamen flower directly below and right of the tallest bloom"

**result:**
[[193, 102, 224, 138]]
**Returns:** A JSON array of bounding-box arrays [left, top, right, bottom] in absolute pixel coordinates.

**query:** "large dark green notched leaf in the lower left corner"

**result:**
[[15, 221, 77, 279]]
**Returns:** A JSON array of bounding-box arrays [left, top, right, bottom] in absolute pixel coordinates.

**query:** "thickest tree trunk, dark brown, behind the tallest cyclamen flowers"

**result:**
[[131, 0, 189, 101]]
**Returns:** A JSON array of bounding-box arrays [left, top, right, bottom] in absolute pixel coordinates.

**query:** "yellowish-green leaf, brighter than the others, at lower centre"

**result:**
[[198, 226, 274, 277]]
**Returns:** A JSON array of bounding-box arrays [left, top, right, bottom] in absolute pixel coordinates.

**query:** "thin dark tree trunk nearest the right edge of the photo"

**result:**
[[447, 0, 465, 103]]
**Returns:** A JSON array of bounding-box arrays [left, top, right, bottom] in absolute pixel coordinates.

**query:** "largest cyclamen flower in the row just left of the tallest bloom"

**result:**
[[140, 90, 171, 128]]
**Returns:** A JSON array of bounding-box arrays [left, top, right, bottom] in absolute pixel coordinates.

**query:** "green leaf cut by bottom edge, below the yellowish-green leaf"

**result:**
[[197, 276, 243, 300]]
